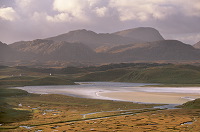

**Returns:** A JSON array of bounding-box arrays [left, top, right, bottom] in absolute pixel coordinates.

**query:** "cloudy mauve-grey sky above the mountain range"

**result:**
[[0, 0, 200, 44]]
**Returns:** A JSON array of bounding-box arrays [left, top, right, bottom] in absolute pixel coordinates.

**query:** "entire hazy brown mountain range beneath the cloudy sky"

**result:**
[[0, 27, 200, 66]]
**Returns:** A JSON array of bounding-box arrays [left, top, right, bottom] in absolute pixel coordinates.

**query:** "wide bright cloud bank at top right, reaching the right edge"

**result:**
[[109, 0, 200, 21]]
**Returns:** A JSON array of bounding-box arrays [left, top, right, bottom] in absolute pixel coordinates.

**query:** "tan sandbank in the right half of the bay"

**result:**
[[98, 92, 200, 104]]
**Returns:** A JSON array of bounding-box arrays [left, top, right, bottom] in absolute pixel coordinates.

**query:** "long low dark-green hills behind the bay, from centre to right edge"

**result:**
[[77, 64, 200, 86]]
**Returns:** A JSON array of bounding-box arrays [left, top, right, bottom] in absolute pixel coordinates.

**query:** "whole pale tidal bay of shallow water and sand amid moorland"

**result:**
[[14, 82, 200, 104]]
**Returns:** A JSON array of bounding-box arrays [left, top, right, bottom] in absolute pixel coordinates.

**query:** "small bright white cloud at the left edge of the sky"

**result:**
[[0, 7, 18, 21]]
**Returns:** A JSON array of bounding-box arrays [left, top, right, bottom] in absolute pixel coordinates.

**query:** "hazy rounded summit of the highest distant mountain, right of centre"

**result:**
[[113, 27, 164, 42]]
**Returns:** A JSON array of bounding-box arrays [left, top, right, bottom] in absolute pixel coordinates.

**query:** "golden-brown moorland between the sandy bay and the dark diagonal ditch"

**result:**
[[0, 86, 159, 132]]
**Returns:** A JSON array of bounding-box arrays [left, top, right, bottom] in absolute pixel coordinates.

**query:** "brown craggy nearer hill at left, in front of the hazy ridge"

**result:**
[[9, 39, 99, 61]]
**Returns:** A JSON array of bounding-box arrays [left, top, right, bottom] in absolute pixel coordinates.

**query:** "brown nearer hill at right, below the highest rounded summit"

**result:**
[[105, 40, 200, 62]]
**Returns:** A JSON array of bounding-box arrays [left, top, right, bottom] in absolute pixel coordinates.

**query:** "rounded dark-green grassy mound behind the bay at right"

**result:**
[[116, 66, 200, 84]]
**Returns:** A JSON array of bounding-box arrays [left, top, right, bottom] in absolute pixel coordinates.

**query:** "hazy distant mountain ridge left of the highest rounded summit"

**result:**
[[46, 29, 141, 49]]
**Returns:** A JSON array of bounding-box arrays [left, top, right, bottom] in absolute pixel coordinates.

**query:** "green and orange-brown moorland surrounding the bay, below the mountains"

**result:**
[[0, 63, 200, 132]]
